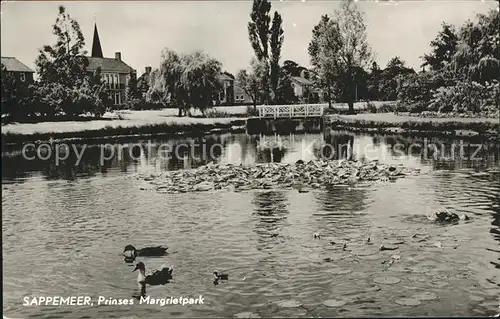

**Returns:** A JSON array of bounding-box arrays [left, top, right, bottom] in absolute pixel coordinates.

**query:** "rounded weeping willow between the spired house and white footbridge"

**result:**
[[146, 49, 222, 116]]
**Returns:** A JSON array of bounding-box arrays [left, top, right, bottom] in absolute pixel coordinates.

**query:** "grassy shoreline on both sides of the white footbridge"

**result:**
[[2, 112, 500, 146]]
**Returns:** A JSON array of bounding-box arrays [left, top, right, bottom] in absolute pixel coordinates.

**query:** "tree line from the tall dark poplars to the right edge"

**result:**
[[237, 0, 500, 113]]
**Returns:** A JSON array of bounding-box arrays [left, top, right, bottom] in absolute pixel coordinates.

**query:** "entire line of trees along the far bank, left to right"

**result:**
[[1, 0, 500, 120]]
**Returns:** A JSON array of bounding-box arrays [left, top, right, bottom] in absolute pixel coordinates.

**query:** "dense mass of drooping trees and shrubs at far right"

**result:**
[[398, 9, 500, 113]]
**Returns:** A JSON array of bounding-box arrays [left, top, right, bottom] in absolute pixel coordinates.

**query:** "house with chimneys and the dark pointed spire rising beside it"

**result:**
[[87, 25, 136, 106]]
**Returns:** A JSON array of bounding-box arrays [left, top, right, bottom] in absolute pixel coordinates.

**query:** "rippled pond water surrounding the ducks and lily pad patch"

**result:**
[[2, 131, 500, 318]]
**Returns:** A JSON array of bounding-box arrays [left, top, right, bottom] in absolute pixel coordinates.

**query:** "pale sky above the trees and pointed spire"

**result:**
[[1, 0, 497, 74]]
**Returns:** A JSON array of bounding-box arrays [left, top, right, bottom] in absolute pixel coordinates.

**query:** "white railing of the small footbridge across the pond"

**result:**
[[257, 104, 328, 119]]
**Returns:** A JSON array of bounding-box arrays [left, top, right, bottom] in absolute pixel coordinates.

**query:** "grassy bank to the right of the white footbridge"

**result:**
[[326, 113, 500, 139]]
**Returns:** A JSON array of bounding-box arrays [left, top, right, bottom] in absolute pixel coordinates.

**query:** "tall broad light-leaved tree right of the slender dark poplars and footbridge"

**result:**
[[309, 0, 371, 113]]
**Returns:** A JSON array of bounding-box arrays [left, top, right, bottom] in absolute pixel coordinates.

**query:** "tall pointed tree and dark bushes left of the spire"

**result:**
[[1, 6, 112, 121]]
